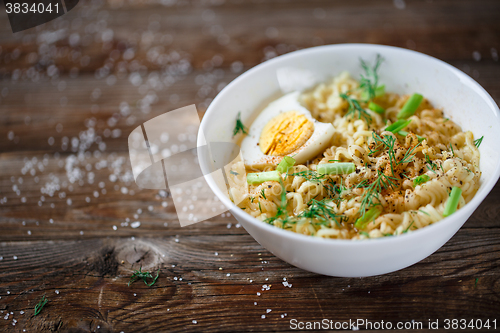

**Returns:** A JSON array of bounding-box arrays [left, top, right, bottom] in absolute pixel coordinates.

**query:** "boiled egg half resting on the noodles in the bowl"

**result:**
[[241, 92, 334, 168]]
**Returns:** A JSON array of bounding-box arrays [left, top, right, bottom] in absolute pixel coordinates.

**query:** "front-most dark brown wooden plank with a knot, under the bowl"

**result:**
[[0, 228, 500, 332]]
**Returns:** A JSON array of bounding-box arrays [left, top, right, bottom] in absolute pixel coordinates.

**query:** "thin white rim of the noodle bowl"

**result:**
[[197, 43, 500, 247]]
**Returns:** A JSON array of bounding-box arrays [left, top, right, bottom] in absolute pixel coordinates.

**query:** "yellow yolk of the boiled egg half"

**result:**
[[259, 111, 314, 156]]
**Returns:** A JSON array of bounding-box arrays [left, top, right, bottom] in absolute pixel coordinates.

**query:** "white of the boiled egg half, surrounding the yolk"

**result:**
[[241, 91, 334, 167]]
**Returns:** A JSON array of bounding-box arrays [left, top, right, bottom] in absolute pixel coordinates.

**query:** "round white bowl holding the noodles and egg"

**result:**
[[198, 44, 500, 277]]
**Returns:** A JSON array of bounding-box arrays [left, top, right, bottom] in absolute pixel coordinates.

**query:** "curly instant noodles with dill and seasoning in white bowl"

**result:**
[[230, 59, 481, 239]]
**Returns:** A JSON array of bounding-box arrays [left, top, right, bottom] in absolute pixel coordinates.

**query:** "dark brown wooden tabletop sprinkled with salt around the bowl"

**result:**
[[0, 0, 500, 333]]
